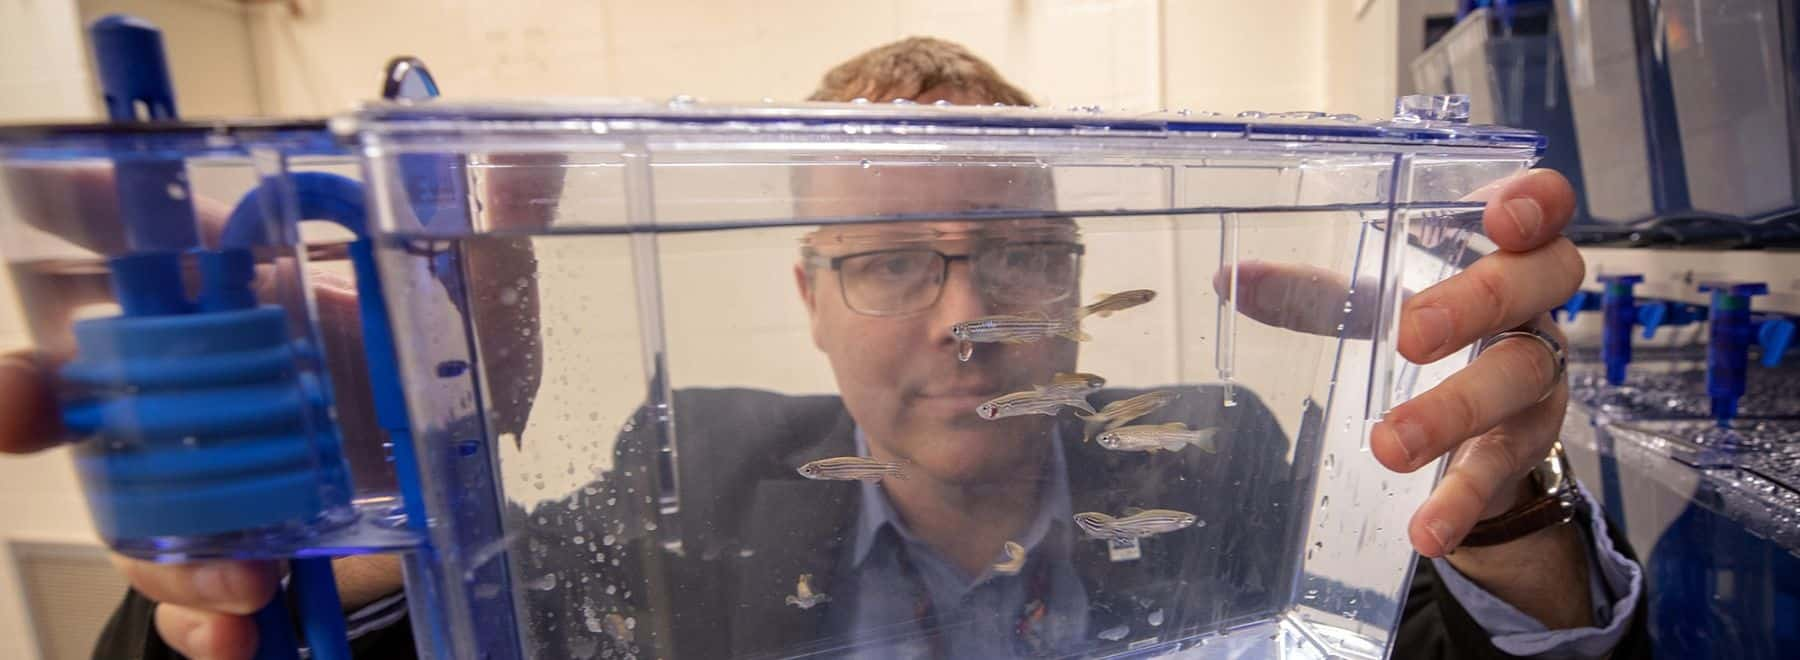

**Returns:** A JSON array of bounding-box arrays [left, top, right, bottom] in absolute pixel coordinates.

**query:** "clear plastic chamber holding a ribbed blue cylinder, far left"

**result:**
[[0, 120, 419, 559]]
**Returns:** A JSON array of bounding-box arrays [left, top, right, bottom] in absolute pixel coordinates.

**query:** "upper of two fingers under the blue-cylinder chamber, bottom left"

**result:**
[[113, 557, 279, 615]]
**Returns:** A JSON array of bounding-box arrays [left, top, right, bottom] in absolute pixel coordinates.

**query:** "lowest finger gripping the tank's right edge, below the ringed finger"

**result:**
[[1408, 387, 1568, 557]]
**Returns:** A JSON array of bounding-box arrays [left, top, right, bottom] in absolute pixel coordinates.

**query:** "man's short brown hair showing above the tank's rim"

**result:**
[[806, 36, 1031, 106]]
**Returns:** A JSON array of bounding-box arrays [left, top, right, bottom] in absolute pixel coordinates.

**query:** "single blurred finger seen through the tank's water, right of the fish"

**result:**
[[1213, 261, 1379, 338]]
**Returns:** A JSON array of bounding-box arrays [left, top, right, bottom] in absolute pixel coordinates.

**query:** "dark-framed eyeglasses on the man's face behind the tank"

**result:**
[[812, 241, 1085, 317]]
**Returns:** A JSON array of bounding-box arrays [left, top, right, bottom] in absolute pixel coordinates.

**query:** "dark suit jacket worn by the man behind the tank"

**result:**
[[97, 387, 1649, 658]]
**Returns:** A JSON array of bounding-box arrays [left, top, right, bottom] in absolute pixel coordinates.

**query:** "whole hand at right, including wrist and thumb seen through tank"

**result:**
[[1213, 169, 1593, 628]]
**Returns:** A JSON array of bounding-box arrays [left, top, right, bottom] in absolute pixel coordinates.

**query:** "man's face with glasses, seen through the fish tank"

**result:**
[[796, 167, 1078, 486]]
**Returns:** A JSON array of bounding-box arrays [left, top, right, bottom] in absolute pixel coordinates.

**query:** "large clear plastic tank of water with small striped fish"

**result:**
[[347, 97, 1543, 658]]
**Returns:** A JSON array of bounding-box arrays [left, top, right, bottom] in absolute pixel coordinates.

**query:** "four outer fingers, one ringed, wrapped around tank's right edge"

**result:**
[[1370, 169, 1586, 557]]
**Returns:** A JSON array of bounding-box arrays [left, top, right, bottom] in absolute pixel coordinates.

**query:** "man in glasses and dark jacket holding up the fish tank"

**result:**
[[0, 40, 1645, 658]]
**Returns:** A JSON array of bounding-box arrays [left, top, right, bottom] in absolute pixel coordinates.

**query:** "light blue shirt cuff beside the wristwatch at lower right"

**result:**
[[1431, 484, 1643, 660]]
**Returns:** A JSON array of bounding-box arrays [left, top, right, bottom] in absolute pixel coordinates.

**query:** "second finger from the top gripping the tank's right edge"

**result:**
[[1399, 237, 1588, 363]]
